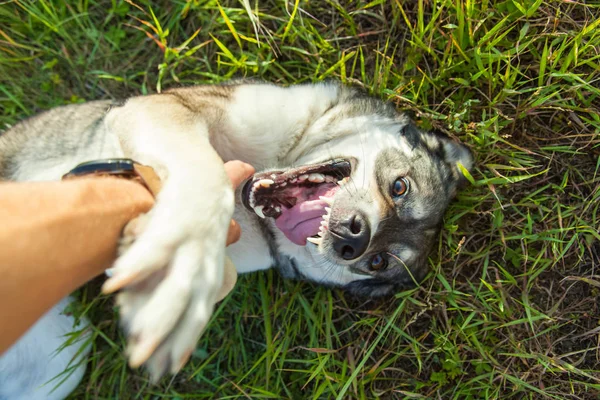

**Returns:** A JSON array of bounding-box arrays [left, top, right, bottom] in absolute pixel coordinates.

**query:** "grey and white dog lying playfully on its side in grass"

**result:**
[[0, 81, 473, 399]]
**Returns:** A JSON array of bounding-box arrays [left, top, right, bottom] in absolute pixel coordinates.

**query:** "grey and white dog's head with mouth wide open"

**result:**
[[243, 85, 472, 296]]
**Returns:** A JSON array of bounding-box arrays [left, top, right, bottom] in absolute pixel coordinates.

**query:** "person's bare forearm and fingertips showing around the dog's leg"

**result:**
[[0, 161, 254, 354]]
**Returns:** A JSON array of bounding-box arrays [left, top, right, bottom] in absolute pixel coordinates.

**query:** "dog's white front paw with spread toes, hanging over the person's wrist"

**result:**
[[103, 183, 233, 381]]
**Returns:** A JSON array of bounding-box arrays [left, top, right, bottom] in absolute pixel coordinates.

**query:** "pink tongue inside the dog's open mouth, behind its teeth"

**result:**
[[275, 187, 338, 246]]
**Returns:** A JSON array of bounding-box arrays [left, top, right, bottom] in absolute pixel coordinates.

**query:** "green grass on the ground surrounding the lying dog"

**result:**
[[0, 0, 600, 399]]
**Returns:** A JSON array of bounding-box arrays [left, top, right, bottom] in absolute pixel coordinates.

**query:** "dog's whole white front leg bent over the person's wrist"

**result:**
[[99, 95, 234, 379]]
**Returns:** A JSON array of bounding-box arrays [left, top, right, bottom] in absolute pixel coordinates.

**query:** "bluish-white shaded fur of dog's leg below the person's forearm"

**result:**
[[0, 297, 91, 400]]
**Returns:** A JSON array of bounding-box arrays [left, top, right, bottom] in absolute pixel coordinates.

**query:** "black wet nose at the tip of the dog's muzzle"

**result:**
[[329, 213, 371, 260]]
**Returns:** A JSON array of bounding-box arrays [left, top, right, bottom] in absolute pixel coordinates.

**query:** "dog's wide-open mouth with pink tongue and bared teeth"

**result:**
[[242, 159, 352, 246]]
